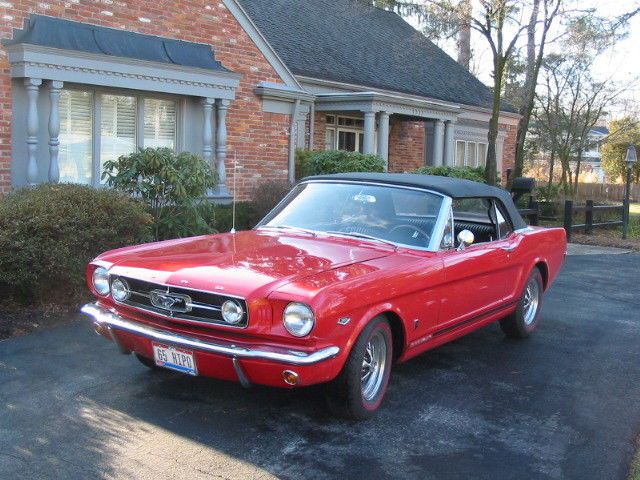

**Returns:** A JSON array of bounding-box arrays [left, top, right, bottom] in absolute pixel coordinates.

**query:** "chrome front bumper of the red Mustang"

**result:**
[[80, 303, 340, 365]]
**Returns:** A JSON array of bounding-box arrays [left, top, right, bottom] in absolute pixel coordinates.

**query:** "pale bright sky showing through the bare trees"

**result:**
[[410, 0, 640, 118]]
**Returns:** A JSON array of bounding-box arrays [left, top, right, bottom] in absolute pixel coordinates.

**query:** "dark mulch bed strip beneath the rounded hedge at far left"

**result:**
[[0, 304, 78, 340]]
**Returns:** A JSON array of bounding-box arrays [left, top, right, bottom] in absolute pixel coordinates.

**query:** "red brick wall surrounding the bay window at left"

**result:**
[[0, 0, 289, 198]]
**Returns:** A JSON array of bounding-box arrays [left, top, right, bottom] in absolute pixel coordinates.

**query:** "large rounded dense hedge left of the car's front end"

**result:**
[[0, 185, 153, 303]]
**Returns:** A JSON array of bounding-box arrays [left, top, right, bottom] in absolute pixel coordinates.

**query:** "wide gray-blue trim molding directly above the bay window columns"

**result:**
[[7, 43, 241, 100]]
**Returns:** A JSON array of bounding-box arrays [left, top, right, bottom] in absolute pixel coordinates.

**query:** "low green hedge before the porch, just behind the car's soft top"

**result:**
[[298, 150, 385, 177]]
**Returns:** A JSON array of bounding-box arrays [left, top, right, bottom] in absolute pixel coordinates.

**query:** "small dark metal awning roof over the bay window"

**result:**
[[3, 15, 228, 72]]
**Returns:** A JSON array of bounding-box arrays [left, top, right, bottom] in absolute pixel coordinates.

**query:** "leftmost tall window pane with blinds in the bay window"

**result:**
[[58, 90, 93, 184]]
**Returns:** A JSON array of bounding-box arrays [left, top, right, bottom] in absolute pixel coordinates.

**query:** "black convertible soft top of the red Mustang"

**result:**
[[302, 173, 527, 230]]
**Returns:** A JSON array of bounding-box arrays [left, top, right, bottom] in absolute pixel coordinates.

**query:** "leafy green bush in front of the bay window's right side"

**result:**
[[102, 148, 217, 240]]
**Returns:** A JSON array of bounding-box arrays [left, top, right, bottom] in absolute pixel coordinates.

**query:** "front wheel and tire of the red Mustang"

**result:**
[[327, 316, 393, 420]]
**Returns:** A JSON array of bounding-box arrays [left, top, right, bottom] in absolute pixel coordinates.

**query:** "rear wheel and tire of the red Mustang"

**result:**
[[500, 268, 544, 338]]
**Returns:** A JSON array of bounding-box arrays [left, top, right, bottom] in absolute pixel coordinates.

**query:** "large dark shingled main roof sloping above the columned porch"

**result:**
[[240, 0, 508, 109]]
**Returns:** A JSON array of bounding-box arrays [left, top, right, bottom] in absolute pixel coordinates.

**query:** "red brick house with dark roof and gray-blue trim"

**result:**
[[0, 0, 518, 200]]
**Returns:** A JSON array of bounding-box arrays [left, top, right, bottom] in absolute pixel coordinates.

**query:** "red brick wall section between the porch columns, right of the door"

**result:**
[[389, 117, 425, 172]]
